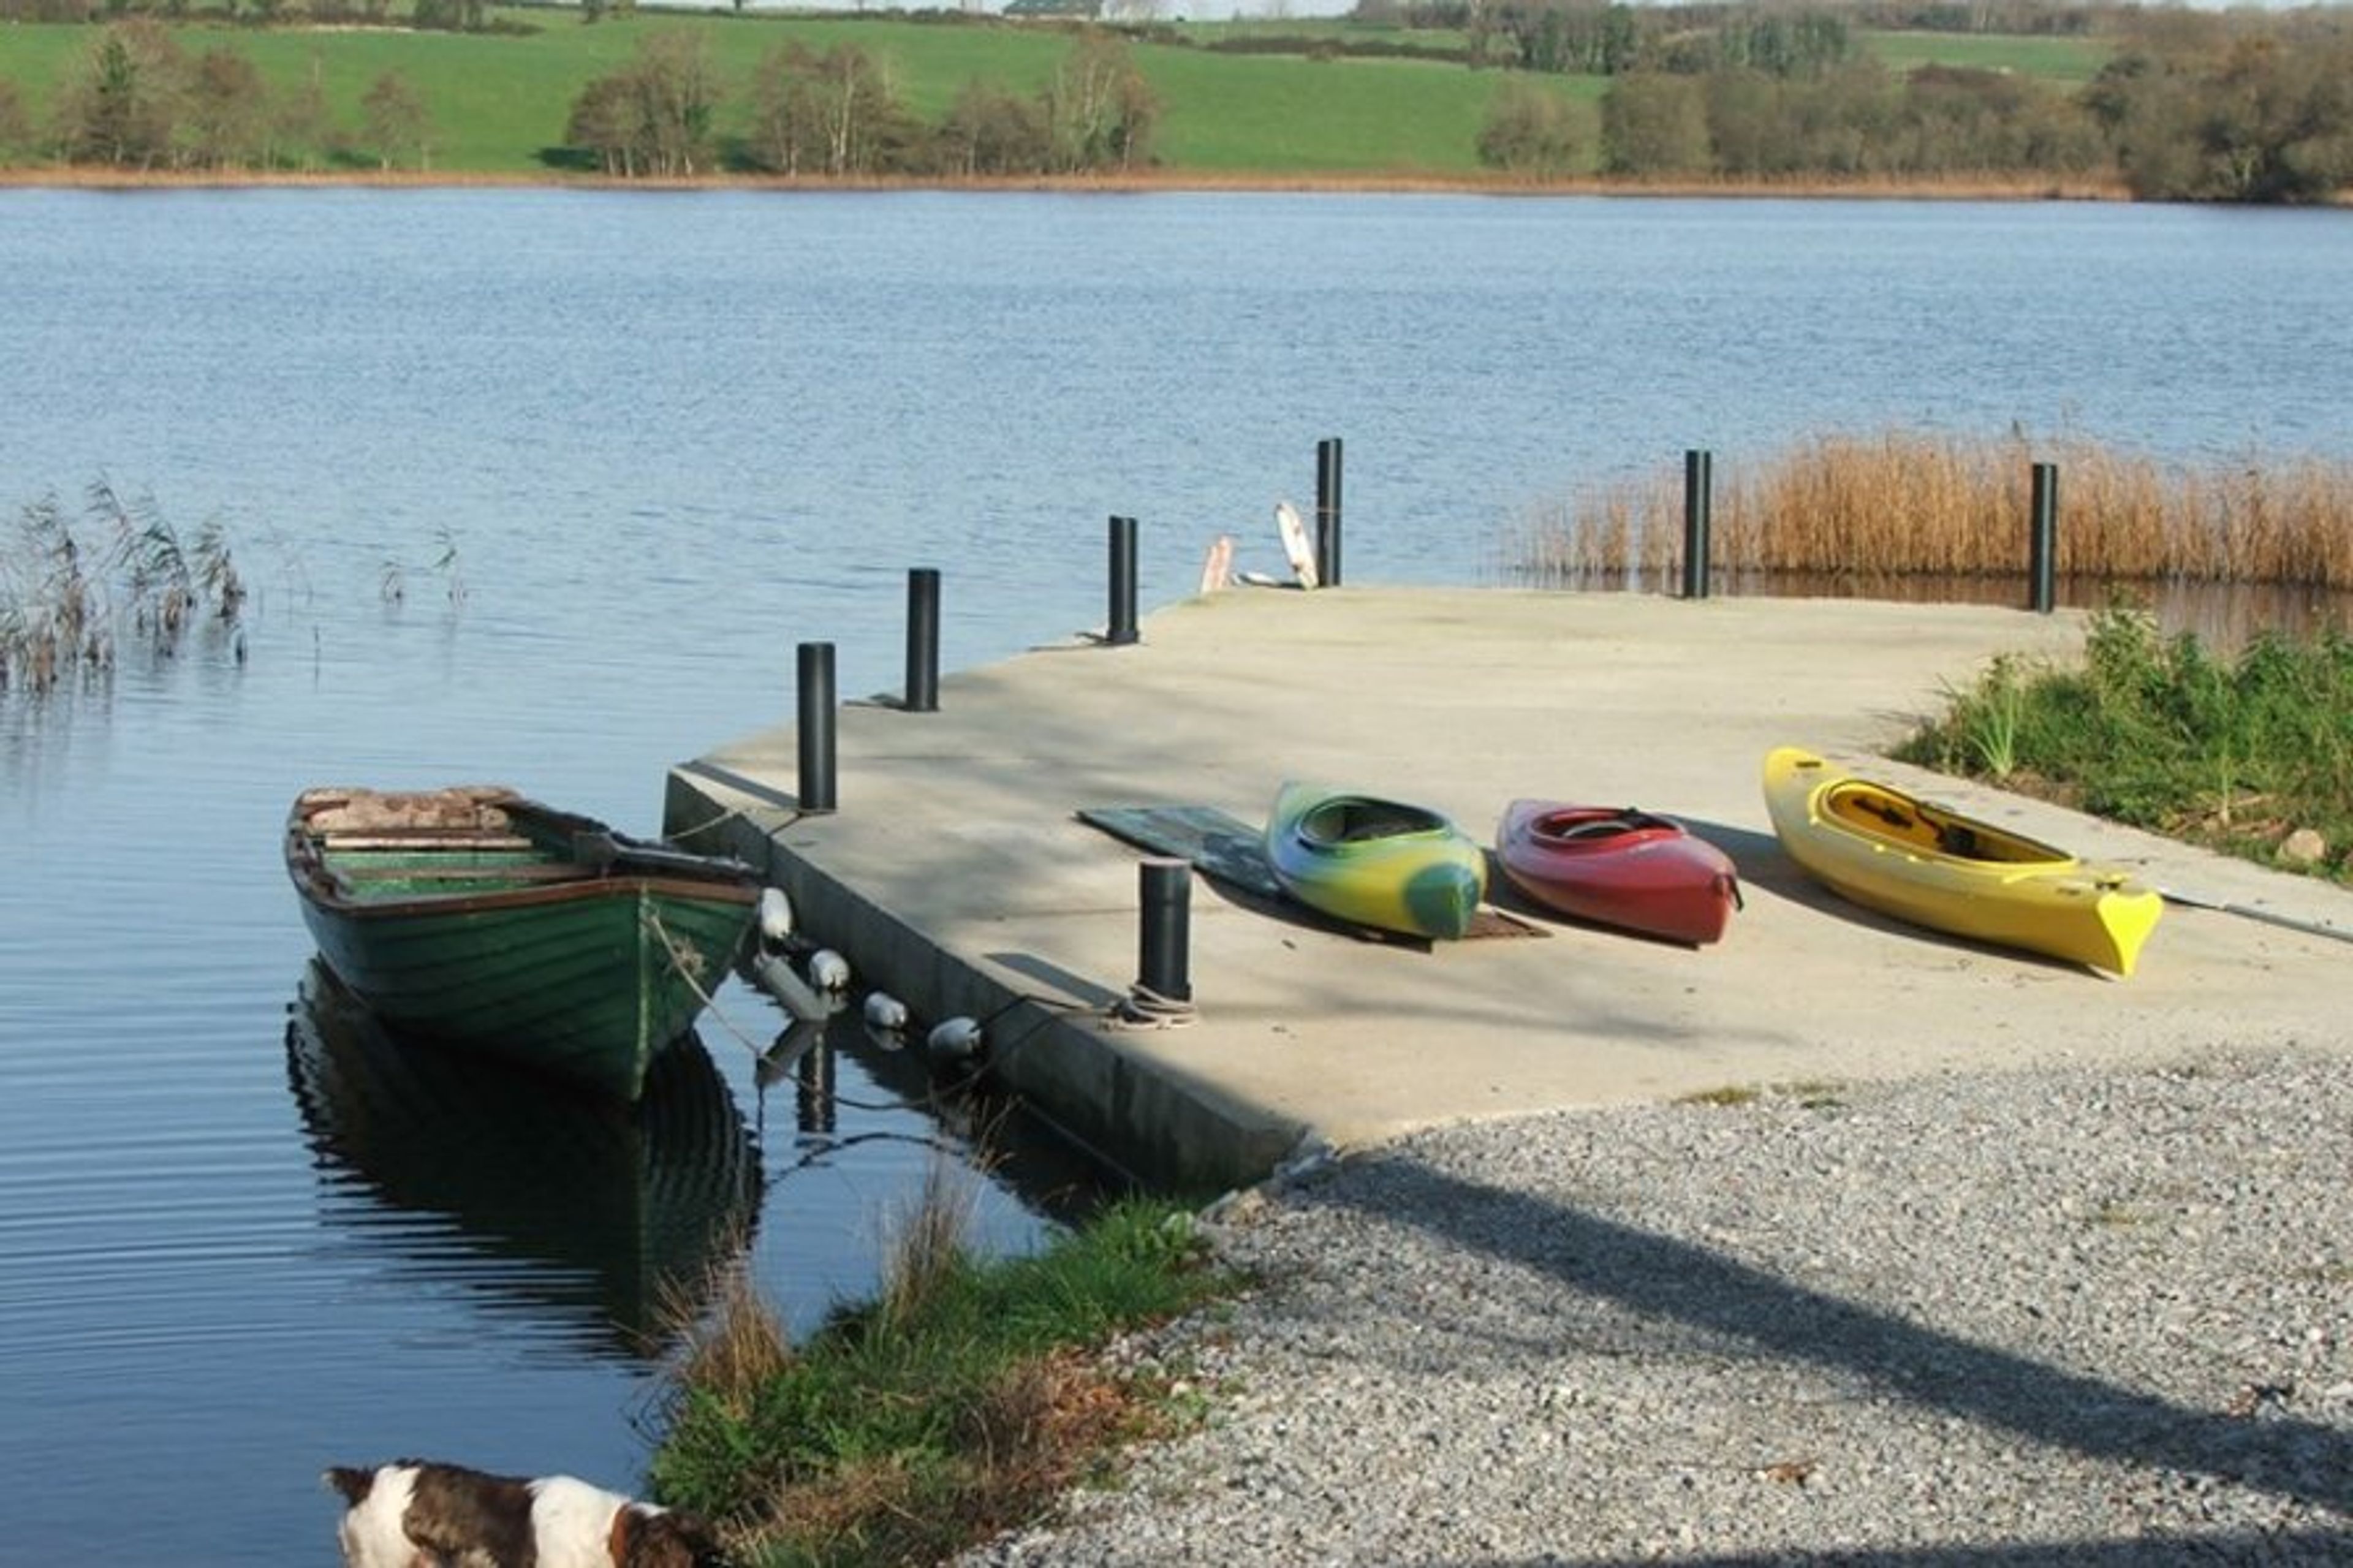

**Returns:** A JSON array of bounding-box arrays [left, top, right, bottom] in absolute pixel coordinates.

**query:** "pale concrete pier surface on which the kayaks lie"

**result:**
[[664, 586, 2353, 1191]]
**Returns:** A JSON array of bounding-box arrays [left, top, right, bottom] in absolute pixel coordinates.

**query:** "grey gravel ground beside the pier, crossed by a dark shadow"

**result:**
[[964, 1050, 2353, 1568]]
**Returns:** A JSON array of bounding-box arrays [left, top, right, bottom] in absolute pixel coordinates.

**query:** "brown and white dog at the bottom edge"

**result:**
[[325, 1460, 727, 1568]]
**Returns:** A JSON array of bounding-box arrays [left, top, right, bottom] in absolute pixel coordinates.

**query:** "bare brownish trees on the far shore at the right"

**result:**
[[1480, 5, 2353, 202]]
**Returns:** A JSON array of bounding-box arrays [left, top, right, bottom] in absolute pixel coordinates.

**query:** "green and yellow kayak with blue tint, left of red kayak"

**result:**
[[1266, 782, 1487, 939]]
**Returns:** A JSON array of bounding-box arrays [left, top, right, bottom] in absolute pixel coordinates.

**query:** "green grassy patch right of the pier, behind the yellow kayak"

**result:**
[[1894, 610, 2353, 883]]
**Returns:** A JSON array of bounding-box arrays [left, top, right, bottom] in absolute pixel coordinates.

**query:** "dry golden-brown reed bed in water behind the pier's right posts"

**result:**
[[1506, 431, 2353, 593]]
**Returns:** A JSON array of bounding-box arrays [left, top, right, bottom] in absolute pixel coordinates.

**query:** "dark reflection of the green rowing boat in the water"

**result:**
[[287, 958, 762, 1356]]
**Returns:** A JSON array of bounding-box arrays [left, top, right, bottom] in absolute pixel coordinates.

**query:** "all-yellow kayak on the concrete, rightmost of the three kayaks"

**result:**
[[1765, 746, 2165, 975]]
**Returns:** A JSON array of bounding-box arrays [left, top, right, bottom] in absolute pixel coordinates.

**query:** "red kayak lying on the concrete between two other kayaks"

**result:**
[[1494, 800, 1741, 947]]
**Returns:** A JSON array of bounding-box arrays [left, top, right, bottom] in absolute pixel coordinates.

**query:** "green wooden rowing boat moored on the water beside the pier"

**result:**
[[285, 786, 760, 1099]]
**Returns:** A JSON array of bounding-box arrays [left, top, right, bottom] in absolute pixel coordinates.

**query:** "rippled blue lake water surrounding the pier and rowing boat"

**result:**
[[0, 191, 2353, 1563]]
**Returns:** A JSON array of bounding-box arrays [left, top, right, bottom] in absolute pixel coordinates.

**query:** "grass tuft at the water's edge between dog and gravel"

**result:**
[[652, 1168, 1230, 1568]]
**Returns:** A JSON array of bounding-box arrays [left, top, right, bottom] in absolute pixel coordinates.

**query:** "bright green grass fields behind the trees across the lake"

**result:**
[[0, 7, 2101, 179]]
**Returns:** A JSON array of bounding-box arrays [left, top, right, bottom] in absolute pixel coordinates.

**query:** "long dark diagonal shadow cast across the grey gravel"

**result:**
[[1327, 1161, 2353, 1516]]
